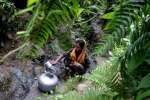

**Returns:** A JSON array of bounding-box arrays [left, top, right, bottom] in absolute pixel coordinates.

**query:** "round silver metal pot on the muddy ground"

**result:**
[[38, 72, 59, 92]]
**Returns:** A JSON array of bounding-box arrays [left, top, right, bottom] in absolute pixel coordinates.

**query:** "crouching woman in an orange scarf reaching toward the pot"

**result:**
[[50, 38, 90, 76]]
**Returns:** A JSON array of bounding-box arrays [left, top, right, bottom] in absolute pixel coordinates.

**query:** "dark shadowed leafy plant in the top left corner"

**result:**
[[0, 0, 17, 47]]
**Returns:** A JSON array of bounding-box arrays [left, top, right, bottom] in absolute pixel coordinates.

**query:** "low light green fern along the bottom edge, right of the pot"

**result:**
[[60, 88, 116, 100]]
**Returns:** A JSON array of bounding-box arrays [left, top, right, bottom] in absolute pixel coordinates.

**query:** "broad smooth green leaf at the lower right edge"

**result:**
[[138, 73, 150, 89]]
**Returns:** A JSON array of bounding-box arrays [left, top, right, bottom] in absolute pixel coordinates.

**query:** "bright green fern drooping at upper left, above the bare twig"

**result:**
[[17, 0, 71, 57]]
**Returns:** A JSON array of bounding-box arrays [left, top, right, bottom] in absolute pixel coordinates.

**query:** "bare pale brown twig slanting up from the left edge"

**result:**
[[0, 42, 29, 64]]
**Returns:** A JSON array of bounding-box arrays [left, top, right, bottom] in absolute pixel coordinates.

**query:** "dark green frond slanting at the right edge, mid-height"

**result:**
[[127, 33, 150, 72]]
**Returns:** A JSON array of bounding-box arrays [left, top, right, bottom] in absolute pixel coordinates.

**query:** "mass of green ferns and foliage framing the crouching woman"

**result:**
[[0, 0, 150, 100]]
